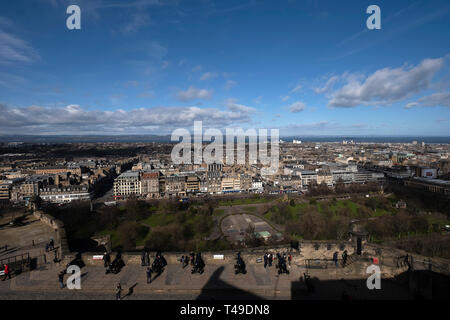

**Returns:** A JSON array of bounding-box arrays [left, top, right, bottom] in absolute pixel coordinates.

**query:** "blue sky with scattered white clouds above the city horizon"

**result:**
[[0, 0, 450, 136]]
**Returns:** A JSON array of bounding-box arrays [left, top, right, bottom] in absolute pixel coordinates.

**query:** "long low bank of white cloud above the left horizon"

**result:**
[[0, 100, 255, 134]]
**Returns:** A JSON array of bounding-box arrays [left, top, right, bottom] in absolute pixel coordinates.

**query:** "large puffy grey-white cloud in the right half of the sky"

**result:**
[[328, 58, 444, 108]]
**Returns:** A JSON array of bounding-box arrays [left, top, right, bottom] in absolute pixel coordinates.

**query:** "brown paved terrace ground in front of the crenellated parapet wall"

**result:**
[[0, 264, 409, 300]]
